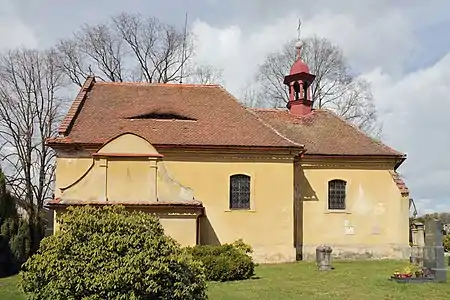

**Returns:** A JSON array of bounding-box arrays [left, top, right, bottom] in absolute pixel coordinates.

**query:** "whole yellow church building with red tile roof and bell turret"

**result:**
[[46, 42, 410, 263]]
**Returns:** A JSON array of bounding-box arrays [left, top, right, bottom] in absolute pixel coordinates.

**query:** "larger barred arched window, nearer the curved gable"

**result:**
[[230, 174, 250, 209]]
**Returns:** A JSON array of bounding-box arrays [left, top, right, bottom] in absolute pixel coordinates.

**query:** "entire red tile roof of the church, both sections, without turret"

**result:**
[[48, 78, 404, 157]]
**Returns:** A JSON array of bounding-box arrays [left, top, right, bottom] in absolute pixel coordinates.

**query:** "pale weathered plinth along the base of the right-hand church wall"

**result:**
[[302, 244, 411, 261]]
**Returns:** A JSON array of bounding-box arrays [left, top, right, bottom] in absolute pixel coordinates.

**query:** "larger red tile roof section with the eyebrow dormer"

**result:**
[[48, 78, 302, 149]]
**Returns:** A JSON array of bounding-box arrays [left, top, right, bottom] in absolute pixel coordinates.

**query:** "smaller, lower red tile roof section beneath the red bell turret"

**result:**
[[253, 109, 404, 157]]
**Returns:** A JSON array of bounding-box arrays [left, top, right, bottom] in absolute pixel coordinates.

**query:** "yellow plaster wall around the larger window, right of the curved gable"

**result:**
[[160, 155, 295, 263]]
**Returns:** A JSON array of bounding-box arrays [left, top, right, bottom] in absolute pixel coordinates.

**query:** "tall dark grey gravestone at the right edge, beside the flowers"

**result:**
[[423, 220, 447, 282]]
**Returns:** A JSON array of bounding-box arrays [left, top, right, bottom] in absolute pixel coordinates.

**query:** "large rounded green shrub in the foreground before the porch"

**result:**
[[21, 206, 206, 300]]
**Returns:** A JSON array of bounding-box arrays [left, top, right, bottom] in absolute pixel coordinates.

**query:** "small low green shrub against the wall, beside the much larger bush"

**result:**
[[187, 241, 255, 281]]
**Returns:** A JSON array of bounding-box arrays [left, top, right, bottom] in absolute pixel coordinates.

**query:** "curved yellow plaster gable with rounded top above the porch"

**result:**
[[57, 133, 193, 204]]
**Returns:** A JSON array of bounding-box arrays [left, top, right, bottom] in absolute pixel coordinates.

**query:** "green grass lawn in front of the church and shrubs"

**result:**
[[0, 261, 450, 300]]
